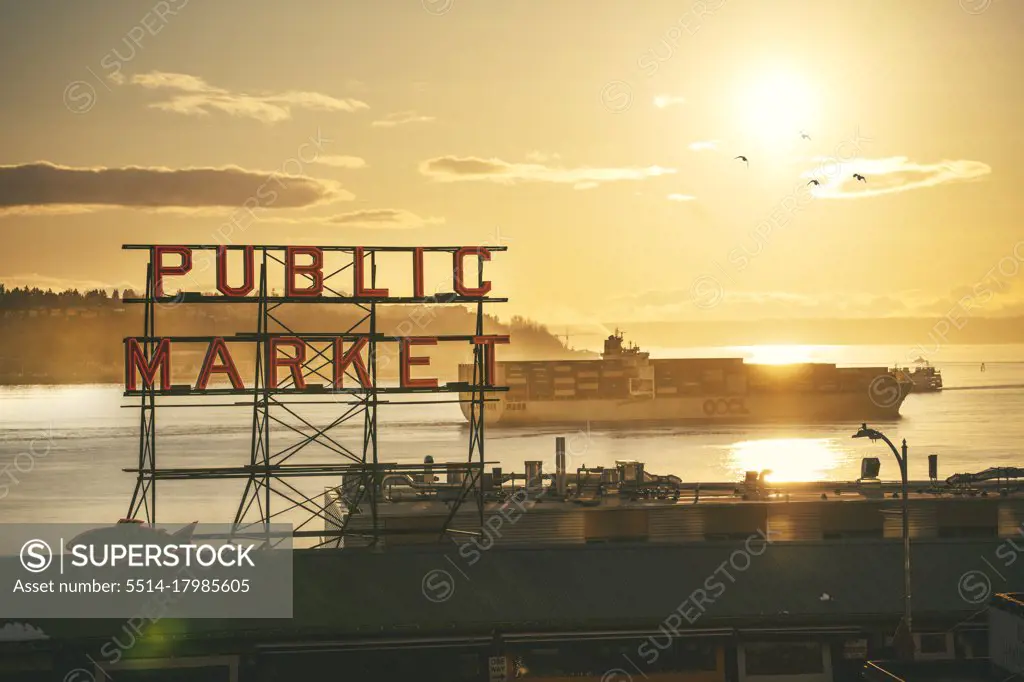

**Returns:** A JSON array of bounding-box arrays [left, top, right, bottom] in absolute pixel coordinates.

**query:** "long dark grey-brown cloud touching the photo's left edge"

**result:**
[[0, 162, 351, 213]]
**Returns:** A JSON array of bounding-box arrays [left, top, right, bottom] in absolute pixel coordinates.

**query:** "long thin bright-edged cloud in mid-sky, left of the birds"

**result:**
[[420, 156, 676, 189]]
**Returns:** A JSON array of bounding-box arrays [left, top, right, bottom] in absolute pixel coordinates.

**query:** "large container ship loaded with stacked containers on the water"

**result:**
[[459, 330, 914, 426]]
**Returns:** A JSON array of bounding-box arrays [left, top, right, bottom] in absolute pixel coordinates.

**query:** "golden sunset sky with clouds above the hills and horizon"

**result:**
[[0, 0, 1024, 325]]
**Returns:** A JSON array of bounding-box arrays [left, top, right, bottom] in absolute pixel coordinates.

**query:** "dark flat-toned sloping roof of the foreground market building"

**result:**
[[8, 538, 1024, 639]]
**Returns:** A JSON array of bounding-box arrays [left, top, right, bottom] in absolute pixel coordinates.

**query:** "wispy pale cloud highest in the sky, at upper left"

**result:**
[[131, 71, 369, 123]]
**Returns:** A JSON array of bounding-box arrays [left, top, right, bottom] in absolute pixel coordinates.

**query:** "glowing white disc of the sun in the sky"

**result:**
[[736, 70, 818, 151]]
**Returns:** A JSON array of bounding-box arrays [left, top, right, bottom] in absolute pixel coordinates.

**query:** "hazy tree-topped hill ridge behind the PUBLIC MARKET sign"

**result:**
[[0, 285, 592, 384]]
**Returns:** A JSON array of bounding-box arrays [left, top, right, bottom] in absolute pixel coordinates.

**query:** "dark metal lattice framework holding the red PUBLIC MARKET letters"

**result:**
[[123, 245, 508, 547]]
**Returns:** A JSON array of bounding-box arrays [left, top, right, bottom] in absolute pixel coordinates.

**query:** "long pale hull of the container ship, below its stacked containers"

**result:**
[[461, 391, 905, 426]]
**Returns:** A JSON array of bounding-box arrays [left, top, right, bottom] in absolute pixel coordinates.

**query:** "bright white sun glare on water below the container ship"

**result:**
[[728, 438, 844, 483]]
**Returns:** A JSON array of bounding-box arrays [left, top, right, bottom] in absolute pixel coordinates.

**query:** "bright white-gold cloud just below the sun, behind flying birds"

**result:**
[[802, 157, 992, 199]]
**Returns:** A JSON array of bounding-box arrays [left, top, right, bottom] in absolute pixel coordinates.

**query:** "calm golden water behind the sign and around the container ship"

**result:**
[[0, 345, 1024, 523]]
